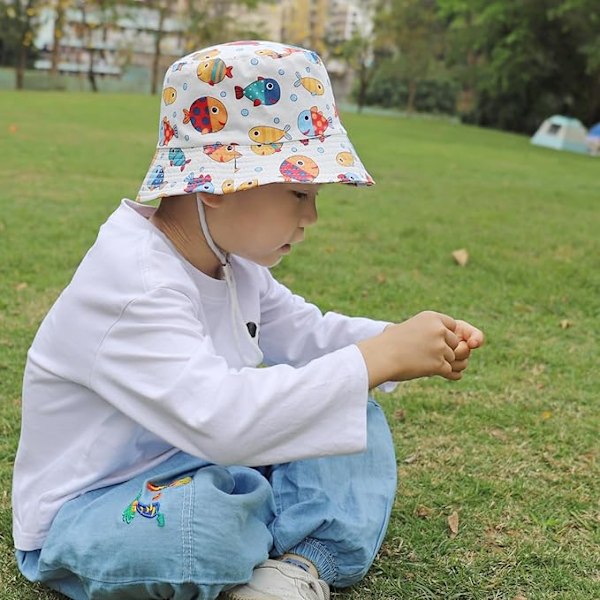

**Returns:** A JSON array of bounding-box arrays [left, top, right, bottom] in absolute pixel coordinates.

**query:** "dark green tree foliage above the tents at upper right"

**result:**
[[370, 0, 600, 132]]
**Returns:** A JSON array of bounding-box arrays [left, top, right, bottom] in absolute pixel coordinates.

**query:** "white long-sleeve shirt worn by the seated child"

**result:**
[[13, 201, 386, 550]]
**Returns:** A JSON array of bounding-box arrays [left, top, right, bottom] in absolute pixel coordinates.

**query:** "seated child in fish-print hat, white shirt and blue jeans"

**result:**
[[13, 41, 483, 600]]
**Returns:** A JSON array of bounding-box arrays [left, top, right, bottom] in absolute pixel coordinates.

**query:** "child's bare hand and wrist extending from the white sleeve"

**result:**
[[357, 311, 483, 388]]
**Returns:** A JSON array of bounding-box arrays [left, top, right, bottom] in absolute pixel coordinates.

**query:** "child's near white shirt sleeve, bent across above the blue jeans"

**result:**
[[89, 288, 368, 466]]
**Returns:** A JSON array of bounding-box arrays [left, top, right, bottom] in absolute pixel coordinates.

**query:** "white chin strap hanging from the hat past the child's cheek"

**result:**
[[196, 193, 263, 366]]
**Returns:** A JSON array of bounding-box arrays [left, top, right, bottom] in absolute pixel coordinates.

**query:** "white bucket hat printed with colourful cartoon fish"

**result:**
[[137, 41, 374, 202]]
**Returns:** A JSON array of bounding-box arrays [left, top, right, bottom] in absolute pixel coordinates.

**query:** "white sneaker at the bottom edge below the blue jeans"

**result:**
[[219, 559, 329, 600]]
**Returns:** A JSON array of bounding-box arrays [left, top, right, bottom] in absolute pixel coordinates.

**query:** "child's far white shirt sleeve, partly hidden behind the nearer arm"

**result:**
[[260, 269, 389, 366]]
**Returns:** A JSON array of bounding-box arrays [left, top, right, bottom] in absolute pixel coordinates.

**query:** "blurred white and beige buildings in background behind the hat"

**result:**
[[35, 0, 372, 96]]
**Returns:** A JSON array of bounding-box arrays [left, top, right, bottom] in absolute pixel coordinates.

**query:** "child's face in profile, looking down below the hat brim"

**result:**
[[202, 183, 319, 267]]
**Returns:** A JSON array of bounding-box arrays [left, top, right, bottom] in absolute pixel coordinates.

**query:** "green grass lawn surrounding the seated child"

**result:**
[[0, 92, 600, 600]]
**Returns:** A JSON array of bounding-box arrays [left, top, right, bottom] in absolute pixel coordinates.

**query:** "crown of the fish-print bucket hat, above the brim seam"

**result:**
[[158, 40, 345, 149]]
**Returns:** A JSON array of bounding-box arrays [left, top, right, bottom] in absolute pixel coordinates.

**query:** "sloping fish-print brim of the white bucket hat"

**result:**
[[137, 133, 374, 202]]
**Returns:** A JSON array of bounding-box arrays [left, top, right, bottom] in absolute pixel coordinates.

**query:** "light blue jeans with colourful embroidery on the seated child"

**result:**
[[17, 400, 396, 600]]
